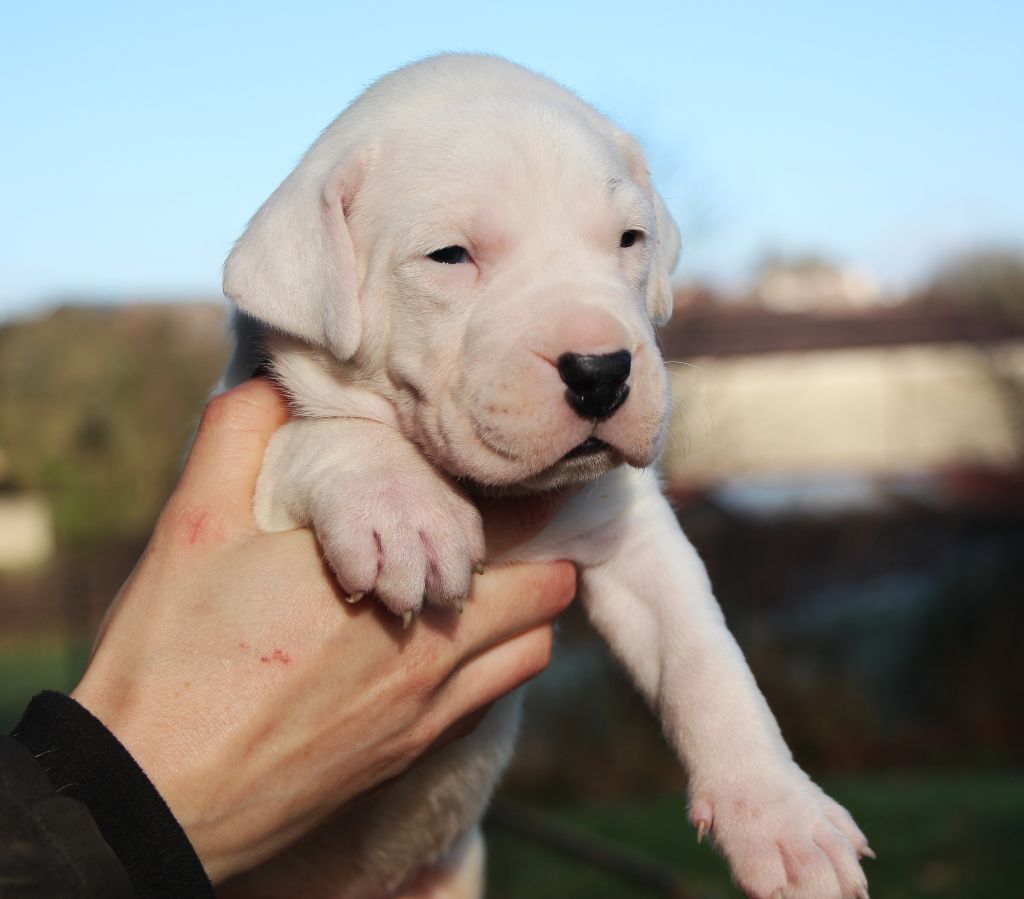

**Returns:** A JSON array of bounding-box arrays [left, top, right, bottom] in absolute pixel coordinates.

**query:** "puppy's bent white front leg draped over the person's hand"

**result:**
[[255, 419, 483, 625]]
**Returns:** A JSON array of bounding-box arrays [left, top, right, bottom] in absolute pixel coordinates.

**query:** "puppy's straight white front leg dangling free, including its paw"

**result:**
[[581, 477, 871, 899]]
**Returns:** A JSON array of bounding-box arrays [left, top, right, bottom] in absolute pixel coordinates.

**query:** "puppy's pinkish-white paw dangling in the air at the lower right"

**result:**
[[690, 765, 874, 899]]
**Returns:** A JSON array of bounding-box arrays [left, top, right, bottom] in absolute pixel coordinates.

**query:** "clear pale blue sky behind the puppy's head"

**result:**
[[0, 0, 1024, 318]]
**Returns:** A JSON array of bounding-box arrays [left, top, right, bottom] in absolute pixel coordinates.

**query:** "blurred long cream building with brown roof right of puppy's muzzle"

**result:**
[[663, 308, 1024, 509]]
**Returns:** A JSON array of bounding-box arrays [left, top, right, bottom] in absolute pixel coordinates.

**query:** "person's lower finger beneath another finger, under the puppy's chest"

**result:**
[[432, 624, 553, 733]]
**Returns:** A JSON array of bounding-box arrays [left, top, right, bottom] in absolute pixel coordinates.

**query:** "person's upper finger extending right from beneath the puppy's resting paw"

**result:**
[[448, 562, 575, 666]]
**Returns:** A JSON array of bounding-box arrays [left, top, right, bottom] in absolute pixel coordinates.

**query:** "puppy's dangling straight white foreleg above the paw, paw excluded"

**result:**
[[583, 498, 790, 777]]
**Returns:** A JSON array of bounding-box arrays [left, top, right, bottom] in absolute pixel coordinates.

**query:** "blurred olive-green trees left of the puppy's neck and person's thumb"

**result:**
[[0, 304, 227, 548]]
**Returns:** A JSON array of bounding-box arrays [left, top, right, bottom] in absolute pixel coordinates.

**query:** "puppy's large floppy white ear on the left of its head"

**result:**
[[224, 156, 364, 359]]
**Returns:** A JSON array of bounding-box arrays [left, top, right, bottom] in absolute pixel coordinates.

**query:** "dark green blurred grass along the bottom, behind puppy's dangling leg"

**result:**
[[487, 773, 1024, 899]]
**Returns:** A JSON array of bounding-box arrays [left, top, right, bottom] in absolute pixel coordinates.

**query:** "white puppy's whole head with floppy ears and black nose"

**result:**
[[224, 55, 679, 489]]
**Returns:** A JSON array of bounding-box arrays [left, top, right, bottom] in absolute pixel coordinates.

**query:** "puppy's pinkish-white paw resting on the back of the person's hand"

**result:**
[[312, 467, 483, 626]]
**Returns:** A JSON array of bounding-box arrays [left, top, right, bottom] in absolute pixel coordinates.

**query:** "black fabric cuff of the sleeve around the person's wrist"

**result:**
[[6, 691, 213, 899]]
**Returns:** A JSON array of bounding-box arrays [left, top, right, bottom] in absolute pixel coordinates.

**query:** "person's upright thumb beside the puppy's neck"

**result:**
[[169, 378, 288, 524]]
